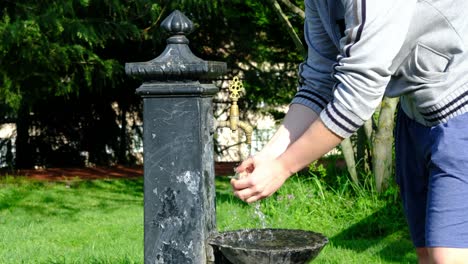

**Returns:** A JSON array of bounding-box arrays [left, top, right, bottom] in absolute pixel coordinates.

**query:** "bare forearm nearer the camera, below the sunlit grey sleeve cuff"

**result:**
[[277, 118, 343, 175]]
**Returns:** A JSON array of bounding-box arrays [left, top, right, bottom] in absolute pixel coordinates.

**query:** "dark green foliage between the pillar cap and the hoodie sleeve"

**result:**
[[179, 0, 304, 110]]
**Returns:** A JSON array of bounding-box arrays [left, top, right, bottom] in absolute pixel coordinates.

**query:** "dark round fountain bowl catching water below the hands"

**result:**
[[208, 229, 328, 264]]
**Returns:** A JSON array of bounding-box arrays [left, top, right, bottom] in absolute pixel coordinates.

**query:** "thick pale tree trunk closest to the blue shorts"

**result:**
[[372, 97, 398, 192]]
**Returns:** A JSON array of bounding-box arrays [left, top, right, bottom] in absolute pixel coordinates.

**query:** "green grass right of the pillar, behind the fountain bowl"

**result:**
[[217, 168, 417, 263]]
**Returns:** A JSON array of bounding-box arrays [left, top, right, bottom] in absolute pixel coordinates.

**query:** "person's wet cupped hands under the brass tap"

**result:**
[[231, 158, 291, 203]]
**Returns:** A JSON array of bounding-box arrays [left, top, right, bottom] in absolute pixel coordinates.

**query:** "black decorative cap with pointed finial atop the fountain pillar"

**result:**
[[125, 10, 227, 81]]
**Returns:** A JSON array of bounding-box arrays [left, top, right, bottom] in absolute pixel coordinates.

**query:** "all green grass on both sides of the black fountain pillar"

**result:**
[[0, 170, 416, 264]]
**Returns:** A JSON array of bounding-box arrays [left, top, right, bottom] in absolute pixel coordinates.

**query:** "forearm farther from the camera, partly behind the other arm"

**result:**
[[257, 104, 318, 159]]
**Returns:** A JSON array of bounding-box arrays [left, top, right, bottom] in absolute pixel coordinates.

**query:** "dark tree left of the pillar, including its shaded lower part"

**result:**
[[0, 0, 160, 168]]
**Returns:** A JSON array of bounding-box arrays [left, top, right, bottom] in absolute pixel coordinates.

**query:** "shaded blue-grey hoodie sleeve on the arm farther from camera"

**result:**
[[292, 0, 339, 114]]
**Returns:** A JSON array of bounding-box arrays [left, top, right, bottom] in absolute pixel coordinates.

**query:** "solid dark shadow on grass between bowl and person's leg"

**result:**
[[330, 208, 417, 263]]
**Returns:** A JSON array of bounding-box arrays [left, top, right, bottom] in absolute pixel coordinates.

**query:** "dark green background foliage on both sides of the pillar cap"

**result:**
[[0, 0, 302, 167]]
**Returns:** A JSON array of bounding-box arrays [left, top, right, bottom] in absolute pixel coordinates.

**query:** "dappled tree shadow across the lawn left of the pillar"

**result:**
[[0, 179, 143, 221]]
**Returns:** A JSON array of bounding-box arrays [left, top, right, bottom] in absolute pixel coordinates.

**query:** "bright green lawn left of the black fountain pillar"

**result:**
[[0, 175, 143, 264]]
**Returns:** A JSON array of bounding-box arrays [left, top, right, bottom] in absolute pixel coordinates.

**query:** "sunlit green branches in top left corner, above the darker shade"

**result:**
[[0, 0, 148, 109]]
